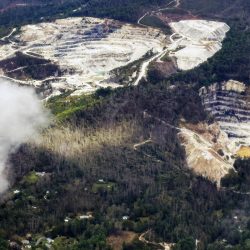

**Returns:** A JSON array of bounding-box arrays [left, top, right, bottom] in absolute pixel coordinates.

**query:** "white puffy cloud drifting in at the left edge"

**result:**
[[0, 80, 48, 193]]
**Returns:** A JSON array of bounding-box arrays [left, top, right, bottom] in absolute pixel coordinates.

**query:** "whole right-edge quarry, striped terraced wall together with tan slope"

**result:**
[[179, 80, 250, 186]]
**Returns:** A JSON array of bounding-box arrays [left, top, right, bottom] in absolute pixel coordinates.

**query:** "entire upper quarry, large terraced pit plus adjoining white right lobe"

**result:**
[[0, 14, 229, 98]]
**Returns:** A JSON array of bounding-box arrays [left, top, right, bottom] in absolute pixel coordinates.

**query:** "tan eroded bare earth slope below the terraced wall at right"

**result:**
[[179, 123, 235, 186]]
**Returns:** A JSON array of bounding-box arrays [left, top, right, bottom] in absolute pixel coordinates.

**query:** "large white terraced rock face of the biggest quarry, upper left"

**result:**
[[0, 17, 166, 97]]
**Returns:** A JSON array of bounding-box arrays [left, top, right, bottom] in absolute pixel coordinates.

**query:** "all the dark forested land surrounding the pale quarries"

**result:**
[[0, 0, 250, 250]]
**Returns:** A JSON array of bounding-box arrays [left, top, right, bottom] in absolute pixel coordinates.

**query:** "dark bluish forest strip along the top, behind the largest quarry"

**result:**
[[0, 0, 170, 36]]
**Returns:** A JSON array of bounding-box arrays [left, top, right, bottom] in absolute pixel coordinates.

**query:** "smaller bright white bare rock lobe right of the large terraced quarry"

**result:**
[[170, 20, 230, 70]]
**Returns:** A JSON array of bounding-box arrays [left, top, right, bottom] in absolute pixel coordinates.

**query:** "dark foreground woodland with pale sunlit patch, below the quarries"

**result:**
[[0, 83, 250, 250]]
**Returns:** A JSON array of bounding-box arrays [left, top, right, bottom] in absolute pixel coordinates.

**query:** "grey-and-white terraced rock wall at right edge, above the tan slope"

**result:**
[[200, 80, 250, 147]]
